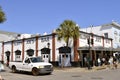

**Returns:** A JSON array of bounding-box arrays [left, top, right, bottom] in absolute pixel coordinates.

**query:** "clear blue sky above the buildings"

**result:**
[[0, 0, 120, 34]]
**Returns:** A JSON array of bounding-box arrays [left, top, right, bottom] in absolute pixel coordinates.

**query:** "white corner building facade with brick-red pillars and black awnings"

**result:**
[[0, 31, 113, 67]]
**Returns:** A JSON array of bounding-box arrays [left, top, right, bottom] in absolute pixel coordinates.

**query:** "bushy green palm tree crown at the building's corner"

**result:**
[[56, 20, 80, 66]]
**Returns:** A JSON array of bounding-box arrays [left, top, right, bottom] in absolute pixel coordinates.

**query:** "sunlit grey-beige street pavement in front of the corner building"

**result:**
[[0, 68, 120, 80]]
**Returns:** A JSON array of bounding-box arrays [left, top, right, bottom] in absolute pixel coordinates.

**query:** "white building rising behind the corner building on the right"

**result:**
[[81, 21, 120, 48]]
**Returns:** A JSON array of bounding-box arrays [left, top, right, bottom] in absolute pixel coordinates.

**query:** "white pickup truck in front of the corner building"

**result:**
[[9, 57, 53, 75]]
